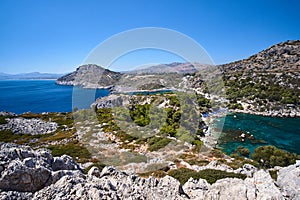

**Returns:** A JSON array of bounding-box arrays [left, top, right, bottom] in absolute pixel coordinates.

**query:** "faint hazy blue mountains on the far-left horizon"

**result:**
[[0, 72, 63, 80]]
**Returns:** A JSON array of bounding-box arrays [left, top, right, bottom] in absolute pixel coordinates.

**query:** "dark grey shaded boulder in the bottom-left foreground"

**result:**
[[0, 143, 81, 192]]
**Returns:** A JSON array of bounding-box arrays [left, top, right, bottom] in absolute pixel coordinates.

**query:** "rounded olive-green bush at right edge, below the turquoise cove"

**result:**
[[252, 146, 300, 168]]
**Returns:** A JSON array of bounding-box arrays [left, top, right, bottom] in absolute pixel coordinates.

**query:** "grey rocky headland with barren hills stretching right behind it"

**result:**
[[56, 63, 203, 92]]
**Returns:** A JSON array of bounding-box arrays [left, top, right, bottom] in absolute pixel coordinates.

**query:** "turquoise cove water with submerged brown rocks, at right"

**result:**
[[213, 113, 300, 154]]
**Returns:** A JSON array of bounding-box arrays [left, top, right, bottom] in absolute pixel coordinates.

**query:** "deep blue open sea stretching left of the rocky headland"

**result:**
[[0, 80, 109, 114]]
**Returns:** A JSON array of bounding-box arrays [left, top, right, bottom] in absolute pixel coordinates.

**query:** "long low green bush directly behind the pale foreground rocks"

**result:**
[[168, 168, 246, 185]]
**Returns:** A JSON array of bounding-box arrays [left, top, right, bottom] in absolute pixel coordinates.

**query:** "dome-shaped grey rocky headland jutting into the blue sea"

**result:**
[[56, 64, 121, 88]]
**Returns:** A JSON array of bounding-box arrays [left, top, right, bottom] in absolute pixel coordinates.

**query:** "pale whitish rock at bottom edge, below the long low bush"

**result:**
[[183, 170, 284, 200]]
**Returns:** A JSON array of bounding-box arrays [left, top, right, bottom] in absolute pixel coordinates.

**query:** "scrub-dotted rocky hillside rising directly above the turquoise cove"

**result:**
[[189, 40, 300, 117]]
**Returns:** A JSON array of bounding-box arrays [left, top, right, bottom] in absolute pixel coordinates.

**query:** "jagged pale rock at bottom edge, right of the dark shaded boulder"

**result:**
[[34, 167, 185, 200]]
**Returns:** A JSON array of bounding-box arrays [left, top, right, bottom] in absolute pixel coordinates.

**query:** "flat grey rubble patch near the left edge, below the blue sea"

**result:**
[[0, 117, 57, 135]]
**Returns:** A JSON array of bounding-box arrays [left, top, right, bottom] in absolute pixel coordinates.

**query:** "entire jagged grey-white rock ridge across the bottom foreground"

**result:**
[[0, 143, 300, 200]]
